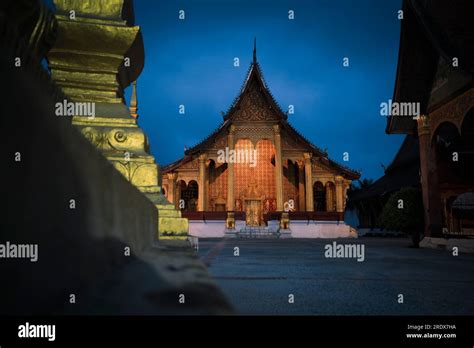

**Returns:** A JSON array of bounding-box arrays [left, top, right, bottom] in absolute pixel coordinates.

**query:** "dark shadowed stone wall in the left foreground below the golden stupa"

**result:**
[[0, 52, 158, 314]]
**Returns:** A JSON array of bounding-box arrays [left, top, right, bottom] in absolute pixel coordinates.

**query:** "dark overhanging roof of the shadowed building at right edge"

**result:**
[[386, 0, 474, 134]]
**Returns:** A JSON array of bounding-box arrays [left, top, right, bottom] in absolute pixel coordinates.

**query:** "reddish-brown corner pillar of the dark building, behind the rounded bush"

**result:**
[[417, 115, 442, 237]]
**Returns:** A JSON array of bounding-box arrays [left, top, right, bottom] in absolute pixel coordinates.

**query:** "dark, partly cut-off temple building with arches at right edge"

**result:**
[[386, 0, 474, 239]]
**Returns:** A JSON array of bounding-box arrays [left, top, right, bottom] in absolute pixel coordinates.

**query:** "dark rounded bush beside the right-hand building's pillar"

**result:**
[[380, 187, 424, 248]]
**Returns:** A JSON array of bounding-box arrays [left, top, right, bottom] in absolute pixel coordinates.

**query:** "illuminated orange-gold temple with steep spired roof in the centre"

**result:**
[[162, 40, 360, 237]]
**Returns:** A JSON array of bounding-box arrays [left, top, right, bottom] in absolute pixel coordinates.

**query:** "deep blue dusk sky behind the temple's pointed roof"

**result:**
[[52, 0, 403, 179]]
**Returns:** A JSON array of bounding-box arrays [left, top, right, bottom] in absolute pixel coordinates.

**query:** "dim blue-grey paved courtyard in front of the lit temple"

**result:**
[[199, 237, 474, 315]]
